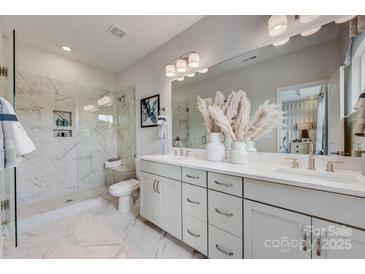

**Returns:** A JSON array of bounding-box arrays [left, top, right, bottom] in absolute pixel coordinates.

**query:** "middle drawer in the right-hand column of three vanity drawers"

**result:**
[[208, 190, 242, 237]]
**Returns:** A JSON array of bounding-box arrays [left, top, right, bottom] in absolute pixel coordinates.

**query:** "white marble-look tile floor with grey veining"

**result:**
[[4, 196, 204, 259]]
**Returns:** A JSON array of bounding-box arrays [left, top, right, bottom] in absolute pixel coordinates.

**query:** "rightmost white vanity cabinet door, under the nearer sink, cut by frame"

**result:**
[[312, 218, 365, 259]]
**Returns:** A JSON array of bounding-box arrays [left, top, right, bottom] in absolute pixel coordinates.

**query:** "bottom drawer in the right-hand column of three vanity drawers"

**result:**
[[209, 225, 243, 259]]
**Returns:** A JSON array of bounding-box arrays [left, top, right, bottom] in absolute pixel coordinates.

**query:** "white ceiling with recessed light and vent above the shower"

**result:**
[[0, 15, 203, 73]]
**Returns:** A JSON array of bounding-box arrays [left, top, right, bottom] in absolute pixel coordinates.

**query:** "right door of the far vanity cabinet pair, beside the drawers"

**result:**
[[157, 177, 182, 239]]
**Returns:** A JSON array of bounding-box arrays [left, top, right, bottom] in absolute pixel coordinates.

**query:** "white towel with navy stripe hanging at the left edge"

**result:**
[[0, 97, 36, 169]]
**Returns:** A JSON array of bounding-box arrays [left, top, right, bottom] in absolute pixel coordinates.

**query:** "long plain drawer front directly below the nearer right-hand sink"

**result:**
[[244, 178, 365, 229]]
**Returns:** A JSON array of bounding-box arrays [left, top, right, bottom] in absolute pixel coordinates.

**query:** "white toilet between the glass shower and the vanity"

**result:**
[[109, 160, 140, 212]]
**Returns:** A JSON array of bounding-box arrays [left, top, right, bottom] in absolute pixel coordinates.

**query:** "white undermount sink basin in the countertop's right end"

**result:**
[[275, 168, 360, 184]]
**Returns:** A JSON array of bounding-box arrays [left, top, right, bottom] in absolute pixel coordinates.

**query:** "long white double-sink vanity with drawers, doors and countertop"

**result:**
[[141, 155, 365, 259]]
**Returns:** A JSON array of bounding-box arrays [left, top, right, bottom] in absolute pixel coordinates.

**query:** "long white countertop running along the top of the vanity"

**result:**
[[139, 154, 365, 198]]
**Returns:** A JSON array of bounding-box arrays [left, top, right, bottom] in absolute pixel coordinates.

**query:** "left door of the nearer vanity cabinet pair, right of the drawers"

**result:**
[[243, 200, 311, 259]]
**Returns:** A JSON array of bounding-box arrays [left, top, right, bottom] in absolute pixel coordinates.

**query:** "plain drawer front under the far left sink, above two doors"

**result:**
[[141, 160, 181, 181]]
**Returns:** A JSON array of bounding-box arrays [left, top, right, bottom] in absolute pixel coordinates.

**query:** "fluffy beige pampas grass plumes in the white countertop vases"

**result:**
[[198, 90, 284, 142]]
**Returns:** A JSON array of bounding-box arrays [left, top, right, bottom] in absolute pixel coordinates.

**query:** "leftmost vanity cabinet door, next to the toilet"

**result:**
[[141, 172, 160, 225]]
